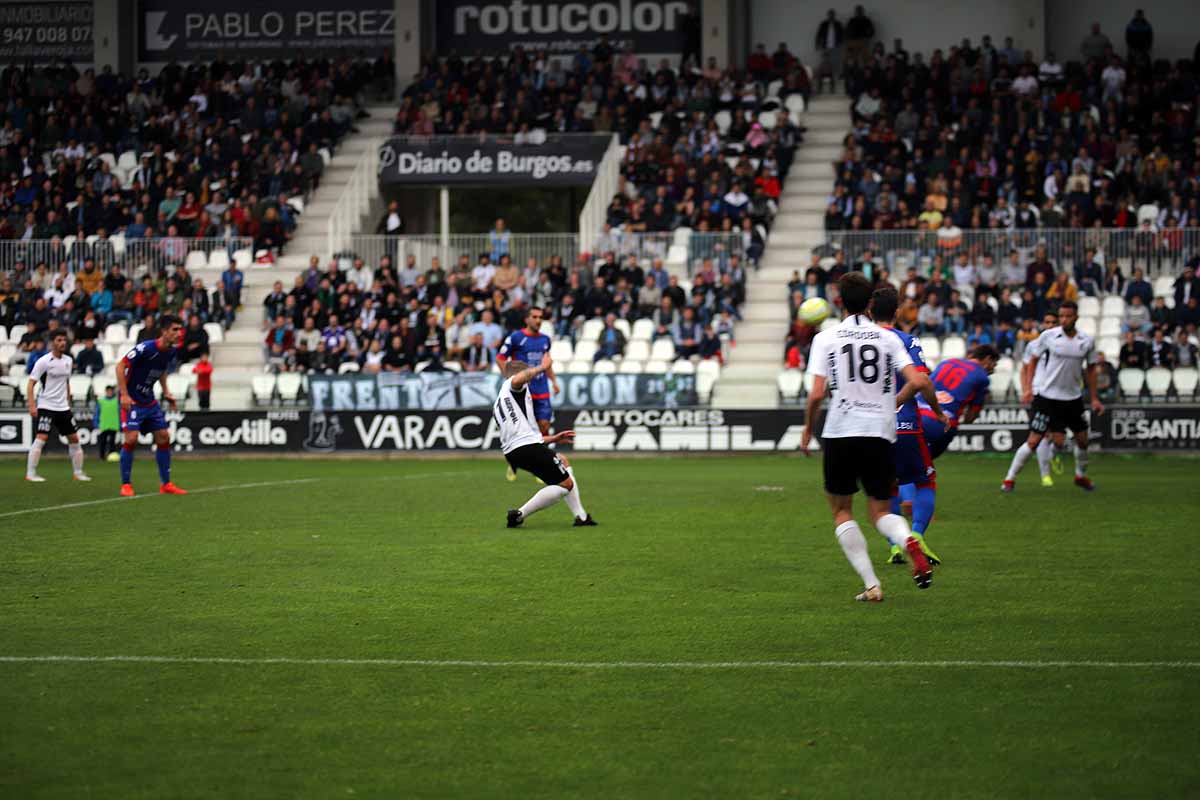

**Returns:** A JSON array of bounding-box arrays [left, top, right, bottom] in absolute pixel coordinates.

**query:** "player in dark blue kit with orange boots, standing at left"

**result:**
[[116, 314, 187, 498]]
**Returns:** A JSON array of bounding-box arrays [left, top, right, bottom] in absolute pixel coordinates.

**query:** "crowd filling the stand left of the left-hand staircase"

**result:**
[[0, 60, 392, 381]]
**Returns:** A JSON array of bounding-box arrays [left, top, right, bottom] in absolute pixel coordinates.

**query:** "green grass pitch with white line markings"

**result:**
[[0, 453, 1200, 799]]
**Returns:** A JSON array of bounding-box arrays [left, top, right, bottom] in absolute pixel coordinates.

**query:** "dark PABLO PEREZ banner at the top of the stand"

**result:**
[[138, 0, 396, 61]]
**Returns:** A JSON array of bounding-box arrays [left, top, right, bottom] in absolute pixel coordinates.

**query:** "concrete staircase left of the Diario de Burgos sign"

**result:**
[[193, 104, 396, 408]]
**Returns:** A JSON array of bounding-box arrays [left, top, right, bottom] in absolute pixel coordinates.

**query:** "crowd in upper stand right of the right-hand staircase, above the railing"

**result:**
[[818, 12, 1200, 242]]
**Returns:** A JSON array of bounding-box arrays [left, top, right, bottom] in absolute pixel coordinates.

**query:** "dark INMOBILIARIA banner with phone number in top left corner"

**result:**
[[0, 0, 96, 64]]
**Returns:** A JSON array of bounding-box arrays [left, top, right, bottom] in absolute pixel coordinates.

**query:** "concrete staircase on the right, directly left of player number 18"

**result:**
[[713, 95, 850, 408]]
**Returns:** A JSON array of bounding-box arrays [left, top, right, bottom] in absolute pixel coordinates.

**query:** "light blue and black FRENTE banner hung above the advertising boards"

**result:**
[[308, 372, 696, 411]]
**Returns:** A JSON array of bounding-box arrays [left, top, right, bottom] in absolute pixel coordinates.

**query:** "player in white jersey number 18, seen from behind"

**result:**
[[800, 272, 949, 602]]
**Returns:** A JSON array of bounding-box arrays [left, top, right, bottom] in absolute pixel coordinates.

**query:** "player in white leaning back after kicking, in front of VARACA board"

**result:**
[[492, 353, 596, 528]]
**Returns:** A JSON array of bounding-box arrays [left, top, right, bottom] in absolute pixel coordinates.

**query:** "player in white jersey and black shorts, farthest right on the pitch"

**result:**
[[1000, 301, 1104, 492]]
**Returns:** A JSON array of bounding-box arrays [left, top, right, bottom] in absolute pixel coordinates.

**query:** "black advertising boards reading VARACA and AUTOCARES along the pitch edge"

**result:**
[[9, 403, 1200, 455]]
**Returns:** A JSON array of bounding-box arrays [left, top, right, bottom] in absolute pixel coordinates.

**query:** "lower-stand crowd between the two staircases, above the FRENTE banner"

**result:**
[[263, 225, 746, 372]]
